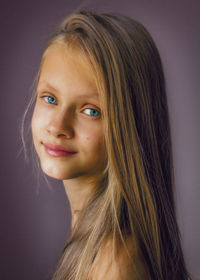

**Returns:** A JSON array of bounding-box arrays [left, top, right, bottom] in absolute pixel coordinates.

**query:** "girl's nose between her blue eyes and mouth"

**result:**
[[47, 112, 74, 139]]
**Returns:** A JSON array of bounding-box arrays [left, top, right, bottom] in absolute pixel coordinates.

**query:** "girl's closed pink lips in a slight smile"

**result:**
[[44, 144, 76, 157]]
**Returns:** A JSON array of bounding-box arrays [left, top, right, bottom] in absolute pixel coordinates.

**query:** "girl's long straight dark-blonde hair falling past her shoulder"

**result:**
[[21, 8, 191, 280]]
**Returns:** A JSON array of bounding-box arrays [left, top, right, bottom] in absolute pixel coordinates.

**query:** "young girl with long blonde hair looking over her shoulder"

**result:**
[[21, 11, 189, 280]]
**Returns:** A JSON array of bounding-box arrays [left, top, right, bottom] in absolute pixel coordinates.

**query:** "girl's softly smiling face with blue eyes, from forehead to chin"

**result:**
[[31, 44, 106, 180]]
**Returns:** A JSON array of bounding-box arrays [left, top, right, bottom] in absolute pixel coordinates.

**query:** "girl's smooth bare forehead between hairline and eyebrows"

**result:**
[[38, 44, 97, 97]]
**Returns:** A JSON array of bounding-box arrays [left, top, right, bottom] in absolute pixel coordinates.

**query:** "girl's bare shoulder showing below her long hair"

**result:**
[[89, 236, 150, 280]]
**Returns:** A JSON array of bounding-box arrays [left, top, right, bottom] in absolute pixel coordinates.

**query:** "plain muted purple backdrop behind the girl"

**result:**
[[0, 0, 200, 280]]
